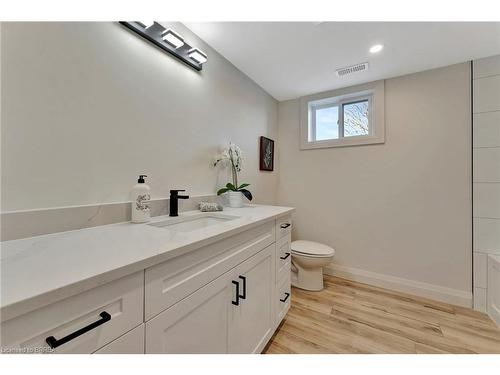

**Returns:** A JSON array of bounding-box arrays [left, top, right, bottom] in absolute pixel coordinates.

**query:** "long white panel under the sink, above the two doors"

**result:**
[[145, 221, 275, 321]]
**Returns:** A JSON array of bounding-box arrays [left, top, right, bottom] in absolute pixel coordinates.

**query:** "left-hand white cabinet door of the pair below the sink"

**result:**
[[146, 273, 233, 353]]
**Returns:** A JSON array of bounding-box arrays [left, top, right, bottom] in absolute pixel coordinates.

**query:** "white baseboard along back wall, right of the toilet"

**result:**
[[324, 263, 472, 307]]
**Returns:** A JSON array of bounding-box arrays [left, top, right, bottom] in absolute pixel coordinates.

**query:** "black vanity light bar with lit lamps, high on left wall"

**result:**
[[120, 21, 207, 71]]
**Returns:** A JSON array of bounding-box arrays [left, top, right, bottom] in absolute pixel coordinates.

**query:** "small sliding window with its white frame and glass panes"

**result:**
[[301, 81, 384, 149]]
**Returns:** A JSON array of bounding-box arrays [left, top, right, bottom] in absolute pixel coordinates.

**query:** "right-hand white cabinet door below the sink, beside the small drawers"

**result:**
[[229, 245, 274, 353]]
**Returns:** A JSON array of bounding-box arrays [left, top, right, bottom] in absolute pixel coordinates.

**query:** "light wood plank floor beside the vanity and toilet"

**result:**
[[264, 276, 500, 354]]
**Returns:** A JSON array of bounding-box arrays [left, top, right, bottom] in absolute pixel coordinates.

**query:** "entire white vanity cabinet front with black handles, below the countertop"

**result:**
[[1, 212, 291, 354]]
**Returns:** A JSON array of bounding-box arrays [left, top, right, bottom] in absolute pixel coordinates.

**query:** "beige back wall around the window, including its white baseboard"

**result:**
[[278, 63, 472, 305]]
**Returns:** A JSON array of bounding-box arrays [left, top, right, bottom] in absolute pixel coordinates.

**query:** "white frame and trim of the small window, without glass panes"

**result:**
[[300, 81, 385, 150]]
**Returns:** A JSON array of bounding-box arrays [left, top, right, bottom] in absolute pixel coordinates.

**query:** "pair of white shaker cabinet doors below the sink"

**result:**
[[146, 245, 274, 353]]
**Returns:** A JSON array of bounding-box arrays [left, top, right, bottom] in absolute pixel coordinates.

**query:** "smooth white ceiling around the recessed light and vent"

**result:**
[[185, 22, 500, 101]]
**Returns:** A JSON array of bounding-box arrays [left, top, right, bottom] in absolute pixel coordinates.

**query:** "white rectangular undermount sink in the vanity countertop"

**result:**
[[148, 213, 238, 233]]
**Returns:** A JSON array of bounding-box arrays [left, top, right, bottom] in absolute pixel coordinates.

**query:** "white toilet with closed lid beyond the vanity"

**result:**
[[291, 240, 335, 291]]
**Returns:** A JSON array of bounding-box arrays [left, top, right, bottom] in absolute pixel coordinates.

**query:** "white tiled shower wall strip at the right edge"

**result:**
[[473, 56, 500, 311]]
